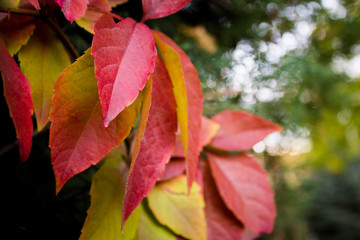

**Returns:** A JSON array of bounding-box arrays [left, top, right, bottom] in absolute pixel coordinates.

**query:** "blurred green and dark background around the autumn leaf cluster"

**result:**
[[0, 0, 360, 240]]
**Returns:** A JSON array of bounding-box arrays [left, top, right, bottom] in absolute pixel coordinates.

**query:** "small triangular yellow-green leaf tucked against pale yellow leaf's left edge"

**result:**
[[134, 204, 176, 240]]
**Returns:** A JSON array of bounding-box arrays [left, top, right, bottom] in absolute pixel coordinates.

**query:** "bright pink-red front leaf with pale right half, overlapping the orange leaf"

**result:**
[[91, 14, 156, 127]]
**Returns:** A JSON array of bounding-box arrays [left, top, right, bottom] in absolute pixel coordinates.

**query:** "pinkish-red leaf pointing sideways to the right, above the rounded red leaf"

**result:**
[[210, 110, 281, 151]]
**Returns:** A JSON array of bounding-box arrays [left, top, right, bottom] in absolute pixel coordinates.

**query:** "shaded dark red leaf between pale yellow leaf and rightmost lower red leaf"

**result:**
[[200, 160, 243, 240]]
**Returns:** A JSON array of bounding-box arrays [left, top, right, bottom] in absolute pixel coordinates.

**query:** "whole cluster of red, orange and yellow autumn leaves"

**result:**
[[0, 0, 280, 239]]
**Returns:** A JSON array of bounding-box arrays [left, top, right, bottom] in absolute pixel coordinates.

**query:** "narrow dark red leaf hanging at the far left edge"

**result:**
[[0, 38, 33, 161]]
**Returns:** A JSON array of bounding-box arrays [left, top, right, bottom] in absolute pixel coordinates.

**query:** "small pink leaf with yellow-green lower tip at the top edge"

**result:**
[[75, 0, 111, 34]]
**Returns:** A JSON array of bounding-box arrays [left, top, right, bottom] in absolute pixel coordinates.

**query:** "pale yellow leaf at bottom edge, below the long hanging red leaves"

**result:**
[[148, 176, 206, 240]]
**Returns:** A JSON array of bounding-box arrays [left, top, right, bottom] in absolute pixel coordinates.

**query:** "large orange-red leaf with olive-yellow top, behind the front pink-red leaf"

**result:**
[[49, 50, 140, 192]]
